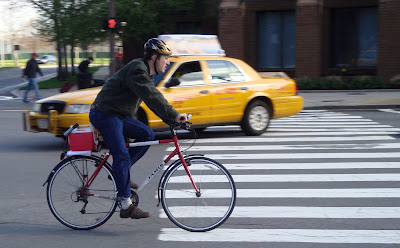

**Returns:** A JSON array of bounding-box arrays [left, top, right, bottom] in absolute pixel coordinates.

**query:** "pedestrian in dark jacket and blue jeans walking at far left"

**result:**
[[21, 53, 43, 102]]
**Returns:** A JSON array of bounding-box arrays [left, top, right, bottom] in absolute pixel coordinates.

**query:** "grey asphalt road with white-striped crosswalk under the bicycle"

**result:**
[[0, 103, 400, 248]]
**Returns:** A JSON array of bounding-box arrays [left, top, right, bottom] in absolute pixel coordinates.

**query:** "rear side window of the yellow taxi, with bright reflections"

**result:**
[[207, 60, 246, 83]]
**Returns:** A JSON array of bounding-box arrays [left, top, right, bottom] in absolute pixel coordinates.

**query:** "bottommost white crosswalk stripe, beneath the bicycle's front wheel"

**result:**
[[158, 228, 400, 243]]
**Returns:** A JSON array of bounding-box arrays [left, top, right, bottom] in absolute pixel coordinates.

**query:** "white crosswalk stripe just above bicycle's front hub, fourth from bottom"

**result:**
[[169, 173, 400, 183]]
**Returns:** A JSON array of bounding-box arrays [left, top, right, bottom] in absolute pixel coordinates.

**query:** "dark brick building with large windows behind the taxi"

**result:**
[[218, 0, 400, 81]]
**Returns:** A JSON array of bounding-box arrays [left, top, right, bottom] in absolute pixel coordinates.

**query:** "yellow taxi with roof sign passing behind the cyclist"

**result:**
[[24, 35, 303, 136]]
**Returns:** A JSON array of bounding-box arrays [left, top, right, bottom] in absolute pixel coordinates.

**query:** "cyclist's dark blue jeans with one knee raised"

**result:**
[[89, 109, 155, 200]]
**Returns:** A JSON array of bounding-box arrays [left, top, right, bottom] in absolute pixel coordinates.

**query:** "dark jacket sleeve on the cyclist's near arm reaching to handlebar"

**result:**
[[126, 67, 179, 124]]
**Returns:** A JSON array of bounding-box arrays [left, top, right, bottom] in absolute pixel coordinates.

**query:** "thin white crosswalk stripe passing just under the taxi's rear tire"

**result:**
[[184, 136, 395, 144]]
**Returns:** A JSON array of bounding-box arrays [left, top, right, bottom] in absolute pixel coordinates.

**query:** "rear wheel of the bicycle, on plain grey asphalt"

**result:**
[[47, 156, 117, 230]]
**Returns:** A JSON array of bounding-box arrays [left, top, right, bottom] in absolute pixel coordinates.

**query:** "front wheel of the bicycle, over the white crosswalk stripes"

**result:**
[[161, 157, 236, 232]]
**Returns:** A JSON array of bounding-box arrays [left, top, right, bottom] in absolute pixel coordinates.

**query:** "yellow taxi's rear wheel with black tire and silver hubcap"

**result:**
[[240, 100, 271, 136]]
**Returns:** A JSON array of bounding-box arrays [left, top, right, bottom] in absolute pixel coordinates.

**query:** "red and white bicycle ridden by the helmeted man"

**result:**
[[43, 117, 236, 232]]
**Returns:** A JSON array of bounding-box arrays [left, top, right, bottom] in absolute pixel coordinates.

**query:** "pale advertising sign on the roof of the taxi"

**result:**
[[158, 34, 225, 56]]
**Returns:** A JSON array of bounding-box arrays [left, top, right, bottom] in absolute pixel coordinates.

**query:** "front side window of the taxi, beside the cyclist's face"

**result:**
[[172, 61, 204, 86]]
